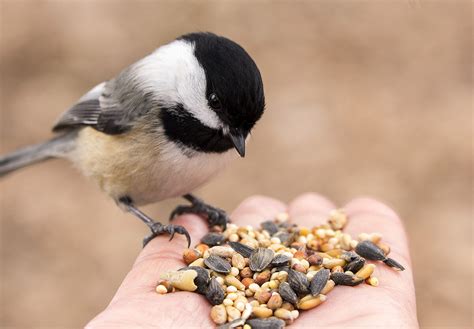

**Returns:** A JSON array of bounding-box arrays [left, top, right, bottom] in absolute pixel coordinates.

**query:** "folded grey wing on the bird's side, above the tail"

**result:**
[[53, 66, 157, 135]]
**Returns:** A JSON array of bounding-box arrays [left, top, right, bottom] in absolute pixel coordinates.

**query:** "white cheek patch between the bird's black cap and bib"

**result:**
[[135, 40, 223, 129]]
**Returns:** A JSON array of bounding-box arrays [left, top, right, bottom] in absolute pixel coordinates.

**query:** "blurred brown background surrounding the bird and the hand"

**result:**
[[0, 0, 473, 327]]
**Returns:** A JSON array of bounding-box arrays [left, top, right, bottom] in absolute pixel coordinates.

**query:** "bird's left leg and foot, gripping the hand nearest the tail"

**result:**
[[119, 197, 191, 248]]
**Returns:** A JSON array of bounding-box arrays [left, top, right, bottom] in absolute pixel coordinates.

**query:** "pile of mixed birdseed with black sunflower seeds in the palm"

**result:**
[[156, 210, 404, 329]]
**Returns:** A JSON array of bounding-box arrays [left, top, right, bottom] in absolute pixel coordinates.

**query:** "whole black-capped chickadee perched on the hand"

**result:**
[[0, 32, 265, 247]]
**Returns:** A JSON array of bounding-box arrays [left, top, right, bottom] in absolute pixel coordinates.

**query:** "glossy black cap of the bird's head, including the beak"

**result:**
[[179, 33, 265, 157]]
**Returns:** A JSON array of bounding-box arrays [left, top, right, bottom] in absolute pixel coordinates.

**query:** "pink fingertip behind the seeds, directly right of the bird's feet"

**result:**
[[230, 195, 287, 228]]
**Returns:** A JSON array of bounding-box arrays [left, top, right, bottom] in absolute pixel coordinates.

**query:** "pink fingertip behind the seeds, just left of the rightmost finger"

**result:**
[[288, 193, 336, 228]]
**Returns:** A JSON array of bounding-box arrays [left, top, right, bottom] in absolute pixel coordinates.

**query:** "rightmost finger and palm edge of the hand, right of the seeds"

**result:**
[[296, 198, 417, 328]]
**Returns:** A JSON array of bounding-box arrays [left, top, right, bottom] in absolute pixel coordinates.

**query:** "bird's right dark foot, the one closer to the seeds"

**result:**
[[170, 194, 229, 230]]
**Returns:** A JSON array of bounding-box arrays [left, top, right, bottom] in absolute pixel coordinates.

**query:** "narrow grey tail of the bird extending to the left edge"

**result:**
[[0, 131, 77, 177]]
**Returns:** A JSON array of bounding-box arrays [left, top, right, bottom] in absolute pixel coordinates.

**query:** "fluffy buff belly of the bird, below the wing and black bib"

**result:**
[[71, 127, 235, 204]]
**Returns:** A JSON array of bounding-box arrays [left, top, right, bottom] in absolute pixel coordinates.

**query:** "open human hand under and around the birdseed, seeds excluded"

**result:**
[[87, 193, 418, 328]]
